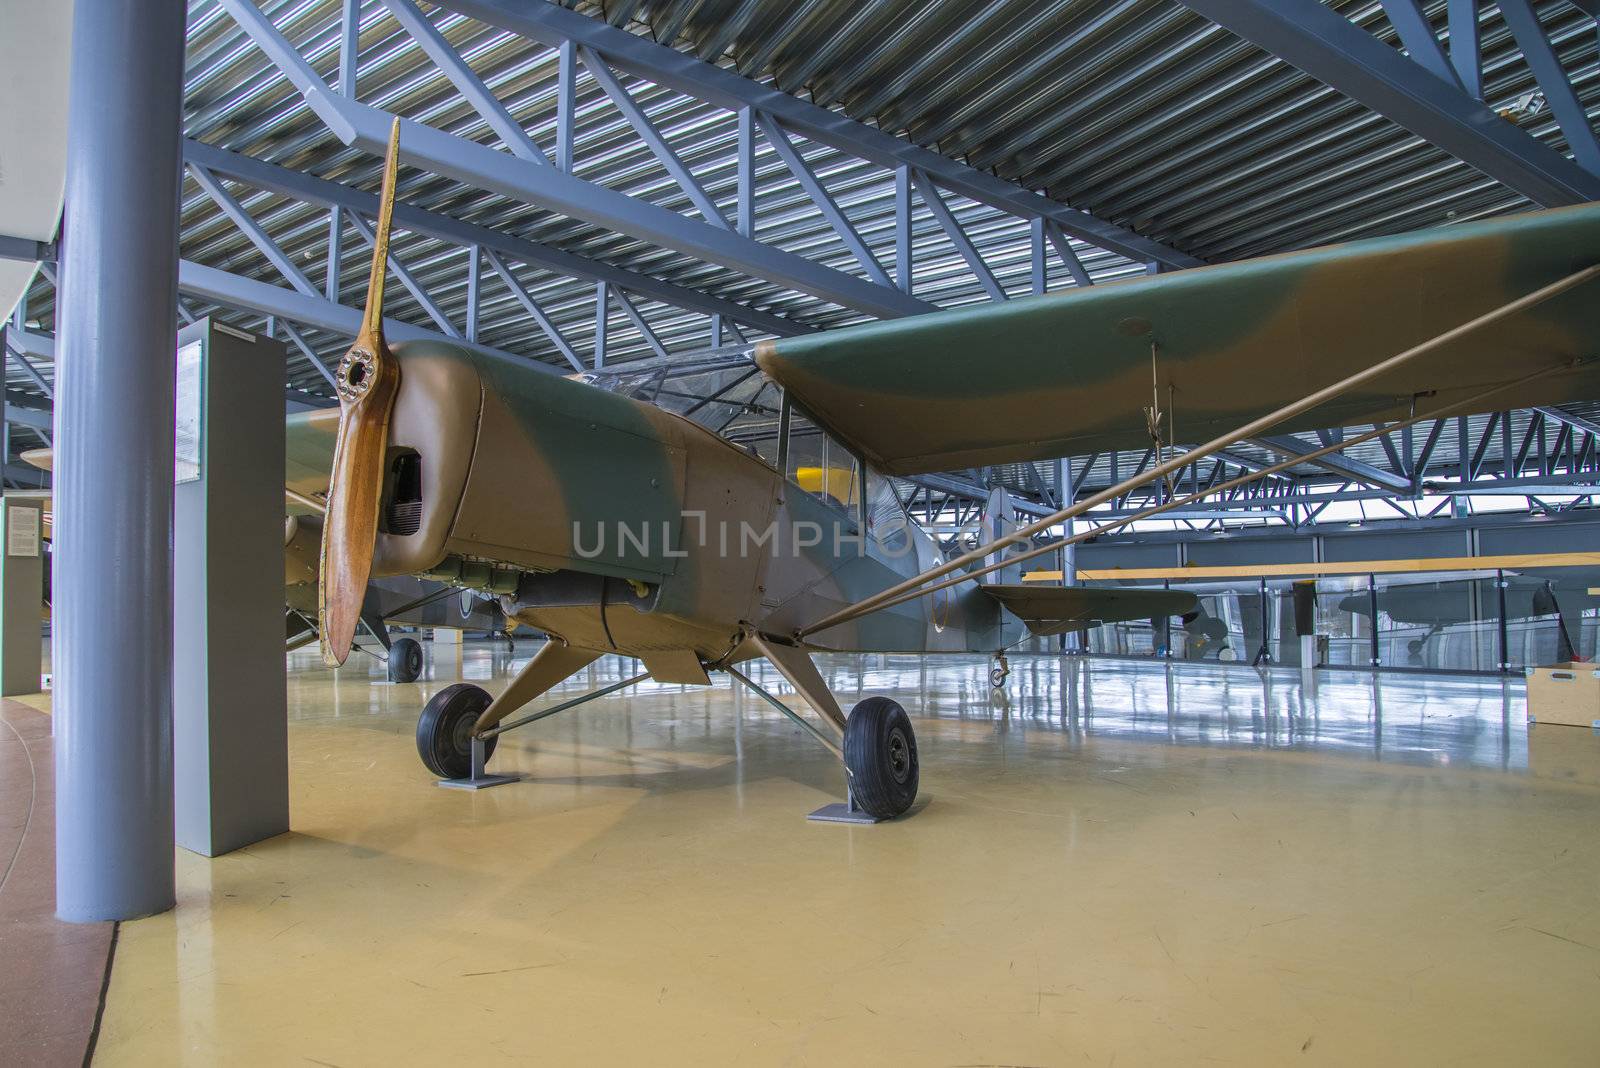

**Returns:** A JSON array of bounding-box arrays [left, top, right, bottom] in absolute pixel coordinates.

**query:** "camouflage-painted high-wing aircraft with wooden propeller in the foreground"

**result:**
[[305, 123, 1600, 817]]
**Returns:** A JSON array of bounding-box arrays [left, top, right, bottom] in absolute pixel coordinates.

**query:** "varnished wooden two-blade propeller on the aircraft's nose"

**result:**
[[317, 118, 400, 667]]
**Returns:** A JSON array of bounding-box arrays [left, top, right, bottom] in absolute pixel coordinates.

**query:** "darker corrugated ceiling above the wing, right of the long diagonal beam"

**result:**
[[578, 0, 1600, 261]]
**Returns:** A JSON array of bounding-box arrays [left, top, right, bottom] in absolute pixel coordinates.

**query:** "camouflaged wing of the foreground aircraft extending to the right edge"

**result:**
[[755, 203, 1600, 475]]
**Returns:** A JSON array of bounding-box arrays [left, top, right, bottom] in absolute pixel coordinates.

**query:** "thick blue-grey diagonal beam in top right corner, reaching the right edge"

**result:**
[[1182, 0, 1600, 208]]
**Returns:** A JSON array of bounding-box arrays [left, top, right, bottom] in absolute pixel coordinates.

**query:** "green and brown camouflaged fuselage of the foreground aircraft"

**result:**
[[374, 342, 1019, 660]]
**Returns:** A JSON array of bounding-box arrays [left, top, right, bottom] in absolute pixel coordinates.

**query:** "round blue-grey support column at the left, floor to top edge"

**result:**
[[53, 0, 184, 921]]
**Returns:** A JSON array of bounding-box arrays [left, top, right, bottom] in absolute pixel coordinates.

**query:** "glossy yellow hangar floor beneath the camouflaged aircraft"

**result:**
[[96, 643, 1600, 1068]]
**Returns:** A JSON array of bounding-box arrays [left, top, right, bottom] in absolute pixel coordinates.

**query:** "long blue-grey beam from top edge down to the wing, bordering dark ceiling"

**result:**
[[425, 0, 1202, 267]]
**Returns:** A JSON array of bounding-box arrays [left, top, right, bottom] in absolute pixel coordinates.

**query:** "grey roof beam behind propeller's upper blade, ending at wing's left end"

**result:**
[[184, 141, 811, 337]]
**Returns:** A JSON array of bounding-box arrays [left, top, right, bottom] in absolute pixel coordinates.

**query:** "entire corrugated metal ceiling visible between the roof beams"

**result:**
[[8, 0, 1600, 498]]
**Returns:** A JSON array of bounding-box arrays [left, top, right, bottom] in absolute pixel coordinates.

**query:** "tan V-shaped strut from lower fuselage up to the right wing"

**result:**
[[795, 265, 1600, 638]]
